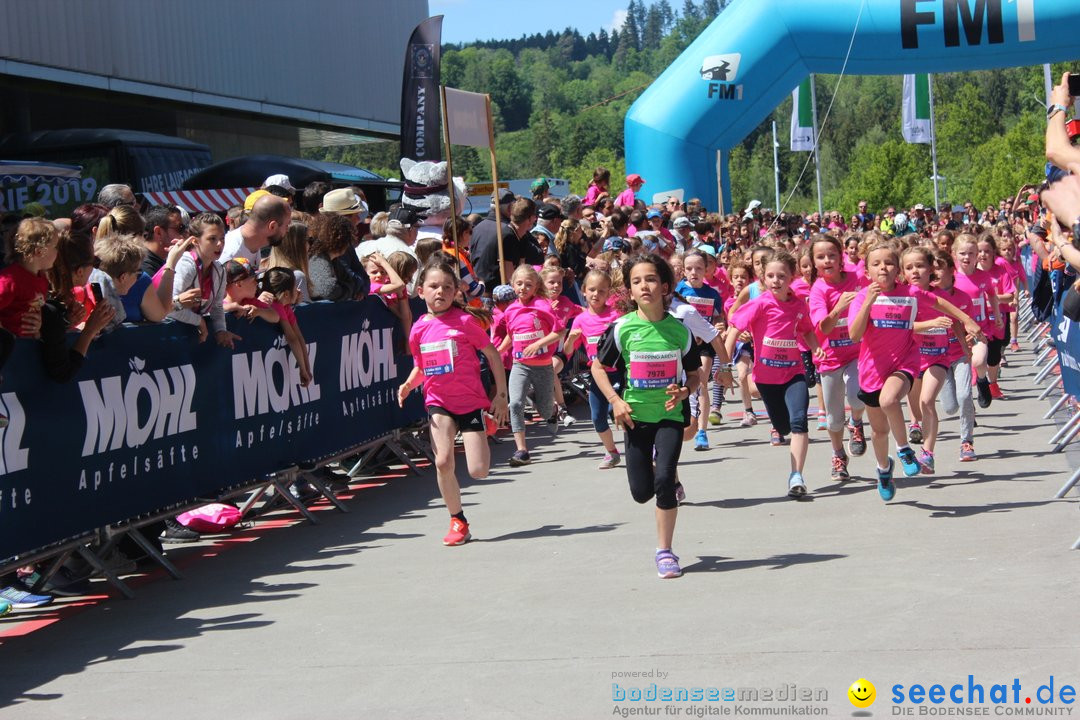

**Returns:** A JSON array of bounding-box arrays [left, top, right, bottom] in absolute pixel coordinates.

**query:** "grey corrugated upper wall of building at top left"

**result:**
[[0, 0, 428, 136]]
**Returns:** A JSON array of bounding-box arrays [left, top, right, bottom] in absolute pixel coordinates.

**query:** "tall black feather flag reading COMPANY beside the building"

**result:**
[[402, 15, 443, 162]]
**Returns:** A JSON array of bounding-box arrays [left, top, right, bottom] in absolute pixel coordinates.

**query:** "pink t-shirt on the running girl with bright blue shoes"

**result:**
[[848, 285, 935, 392]]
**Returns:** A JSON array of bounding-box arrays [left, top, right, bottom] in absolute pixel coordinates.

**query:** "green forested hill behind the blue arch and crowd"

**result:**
[[307, 0, 1080, 212]]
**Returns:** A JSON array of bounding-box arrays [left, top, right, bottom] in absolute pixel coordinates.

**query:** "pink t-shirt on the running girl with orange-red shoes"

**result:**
[[408, 308, 491, 415]]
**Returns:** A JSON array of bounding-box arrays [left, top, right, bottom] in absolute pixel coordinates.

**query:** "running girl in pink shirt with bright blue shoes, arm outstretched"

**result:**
[[848, 243, 977, 501]]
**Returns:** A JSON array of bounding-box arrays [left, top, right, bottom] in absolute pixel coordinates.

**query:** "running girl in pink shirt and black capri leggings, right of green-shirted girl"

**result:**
[[726, 253, 824, 498]]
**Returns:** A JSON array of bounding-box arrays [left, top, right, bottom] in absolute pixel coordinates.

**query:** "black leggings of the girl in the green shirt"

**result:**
[[624, 420, 684, 510]]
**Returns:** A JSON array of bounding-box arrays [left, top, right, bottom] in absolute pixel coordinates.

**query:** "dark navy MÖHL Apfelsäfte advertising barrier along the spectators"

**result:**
[[0, 298, 423, 558]]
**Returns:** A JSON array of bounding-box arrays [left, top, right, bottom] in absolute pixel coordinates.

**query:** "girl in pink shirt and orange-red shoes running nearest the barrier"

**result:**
[[397, 261, 507, 545]]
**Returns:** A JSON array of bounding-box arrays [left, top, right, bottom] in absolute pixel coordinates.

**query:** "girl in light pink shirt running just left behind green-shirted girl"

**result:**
[[563, 270, 623, 470]]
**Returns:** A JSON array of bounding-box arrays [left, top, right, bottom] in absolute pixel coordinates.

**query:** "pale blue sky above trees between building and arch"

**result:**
[[428, 0, 630, 43]]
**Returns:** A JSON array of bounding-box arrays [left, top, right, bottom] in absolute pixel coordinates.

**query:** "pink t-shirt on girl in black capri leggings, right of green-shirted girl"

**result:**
[[731, 291, 813, 385]]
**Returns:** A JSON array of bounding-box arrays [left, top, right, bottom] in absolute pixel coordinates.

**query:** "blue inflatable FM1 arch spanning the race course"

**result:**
[[625, 0, 1080, 212]]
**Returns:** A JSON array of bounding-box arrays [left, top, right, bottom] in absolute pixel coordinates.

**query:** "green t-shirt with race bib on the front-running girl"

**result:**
[[596, 312, 701, 423]]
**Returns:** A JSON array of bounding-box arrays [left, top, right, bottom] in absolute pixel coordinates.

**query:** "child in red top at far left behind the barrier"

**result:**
[[0, 218, 58, 338]]
